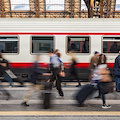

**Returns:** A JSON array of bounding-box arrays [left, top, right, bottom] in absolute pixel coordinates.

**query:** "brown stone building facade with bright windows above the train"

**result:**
[[0, 0, 120, 18]]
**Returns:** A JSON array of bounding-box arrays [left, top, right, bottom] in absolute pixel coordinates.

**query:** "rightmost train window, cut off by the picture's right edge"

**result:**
[[103, 37, 120, 53]]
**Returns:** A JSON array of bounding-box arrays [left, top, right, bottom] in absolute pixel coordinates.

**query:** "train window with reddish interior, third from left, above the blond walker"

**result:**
[[67, 36, 89, 53]]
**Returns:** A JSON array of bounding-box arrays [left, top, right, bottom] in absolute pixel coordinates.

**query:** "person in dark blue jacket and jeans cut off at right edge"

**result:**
[[113, 51, 120, 92]]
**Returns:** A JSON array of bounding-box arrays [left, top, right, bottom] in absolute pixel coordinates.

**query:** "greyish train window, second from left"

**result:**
[[32, 36, 54, 53]]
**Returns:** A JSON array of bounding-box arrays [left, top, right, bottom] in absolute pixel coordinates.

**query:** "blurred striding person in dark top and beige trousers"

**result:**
[[21, 55, 51, 106]]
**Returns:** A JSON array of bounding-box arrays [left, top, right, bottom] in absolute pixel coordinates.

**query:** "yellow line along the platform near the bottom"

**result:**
[[0, 111, 120, 116]]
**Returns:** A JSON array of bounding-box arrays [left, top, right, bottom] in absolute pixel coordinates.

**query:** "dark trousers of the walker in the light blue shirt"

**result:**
[[50, 68, 64, 96]]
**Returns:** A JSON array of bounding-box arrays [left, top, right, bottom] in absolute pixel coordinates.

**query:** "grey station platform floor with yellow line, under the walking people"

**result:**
[[0, 82, 120, 120]]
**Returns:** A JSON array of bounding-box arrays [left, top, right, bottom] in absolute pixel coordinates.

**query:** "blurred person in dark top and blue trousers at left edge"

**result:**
[[0, 53, 13, 87]]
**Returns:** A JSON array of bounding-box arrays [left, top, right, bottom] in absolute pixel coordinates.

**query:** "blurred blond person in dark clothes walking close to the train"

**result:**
[[69, 51, 81, 87]]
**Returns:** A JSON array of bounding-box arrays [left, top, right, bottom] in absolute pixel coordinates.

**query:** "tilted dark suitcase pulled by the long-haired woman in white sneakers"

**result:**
[[76, 84, 96, 105]]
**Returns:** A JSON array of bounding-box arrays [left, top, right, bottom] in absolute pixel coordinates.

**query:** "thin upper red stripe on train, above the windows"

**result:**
[[0, 32, 120, 35]]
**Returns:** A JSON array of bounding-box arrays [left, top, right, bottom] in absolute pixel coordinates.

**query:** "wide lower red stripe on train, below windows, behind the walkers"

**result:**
[[10, 63, 114, 68]]
